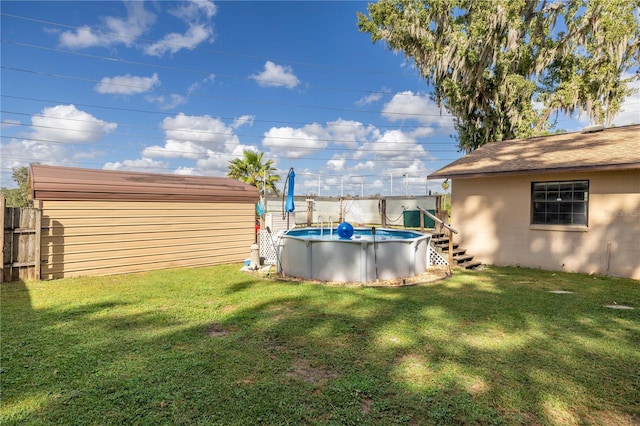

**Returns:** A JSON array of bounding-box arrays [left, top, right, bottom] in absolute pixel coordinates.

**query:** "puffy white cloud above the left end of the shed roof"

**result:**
[[30, 105, 118, 143]]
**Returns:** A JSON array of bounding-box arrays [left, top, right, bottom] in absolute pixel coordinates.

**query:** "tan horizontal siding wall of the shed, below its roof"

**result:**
[[41, 201, 255, 279]]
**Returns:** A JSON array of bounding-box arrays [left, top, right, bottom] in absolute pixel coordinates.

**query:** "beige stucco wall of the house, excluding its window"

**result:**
[[451, 170, 640, 279]]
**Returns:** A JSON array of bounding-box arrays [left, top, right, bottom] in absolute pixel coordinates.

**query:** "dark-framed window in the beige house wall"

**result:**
[[531, 180, 589, 226]]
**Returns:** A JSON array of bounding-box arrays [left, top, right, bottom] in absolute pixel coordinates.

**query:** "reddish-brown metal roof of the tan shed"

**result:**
[[29, 164, 259, 203]]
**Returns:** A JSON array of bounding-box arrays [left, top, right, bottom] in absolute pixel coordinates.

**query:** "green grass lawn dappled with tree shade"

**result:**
[[0, 265, 640, 425]]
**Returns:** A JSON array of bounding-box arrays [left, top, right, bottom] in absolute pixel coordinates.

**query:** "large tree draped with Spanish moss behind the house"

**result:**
[[358, 0, 640, 152]]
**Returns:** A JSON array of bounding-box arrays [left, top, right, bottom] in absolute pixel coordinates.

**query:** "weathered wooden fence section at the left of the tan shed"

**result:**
[[0, 197, 42, 283]]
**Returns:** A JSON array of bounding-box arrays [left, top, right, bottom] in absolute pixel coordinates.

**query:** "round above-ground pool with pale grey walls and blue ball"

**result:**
[[278, 224, 431, 282]]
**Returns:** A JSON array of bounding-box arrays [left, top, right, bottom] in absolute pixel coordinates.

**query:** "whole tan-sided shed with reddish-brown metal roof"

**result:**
[[29, 164, 258, 279]]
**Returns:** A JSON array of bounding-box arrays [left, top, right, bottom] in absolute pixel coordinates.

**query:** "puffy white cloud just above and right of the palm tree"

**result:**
[[262, 123, 329, 158]]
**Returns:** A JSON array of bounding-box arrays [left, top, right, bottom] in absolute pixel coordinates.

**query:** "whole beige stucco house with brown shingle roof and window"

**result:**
[[429, 125, 640, 279]]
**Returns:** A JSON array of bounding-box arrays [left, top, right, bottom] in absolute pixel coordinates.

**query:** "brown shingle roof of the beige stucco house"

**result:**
[[428, 125, 640, 178]]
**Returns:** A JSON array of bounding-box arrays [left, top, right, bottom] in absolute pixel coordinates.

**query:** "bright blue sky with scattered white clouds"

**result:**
[[0, 1, 640, 196]]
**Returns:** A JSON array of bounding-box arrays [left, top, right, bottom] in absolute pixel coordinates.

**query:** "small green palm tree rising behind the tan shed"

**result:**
[[227, 149, 280, 195]]
